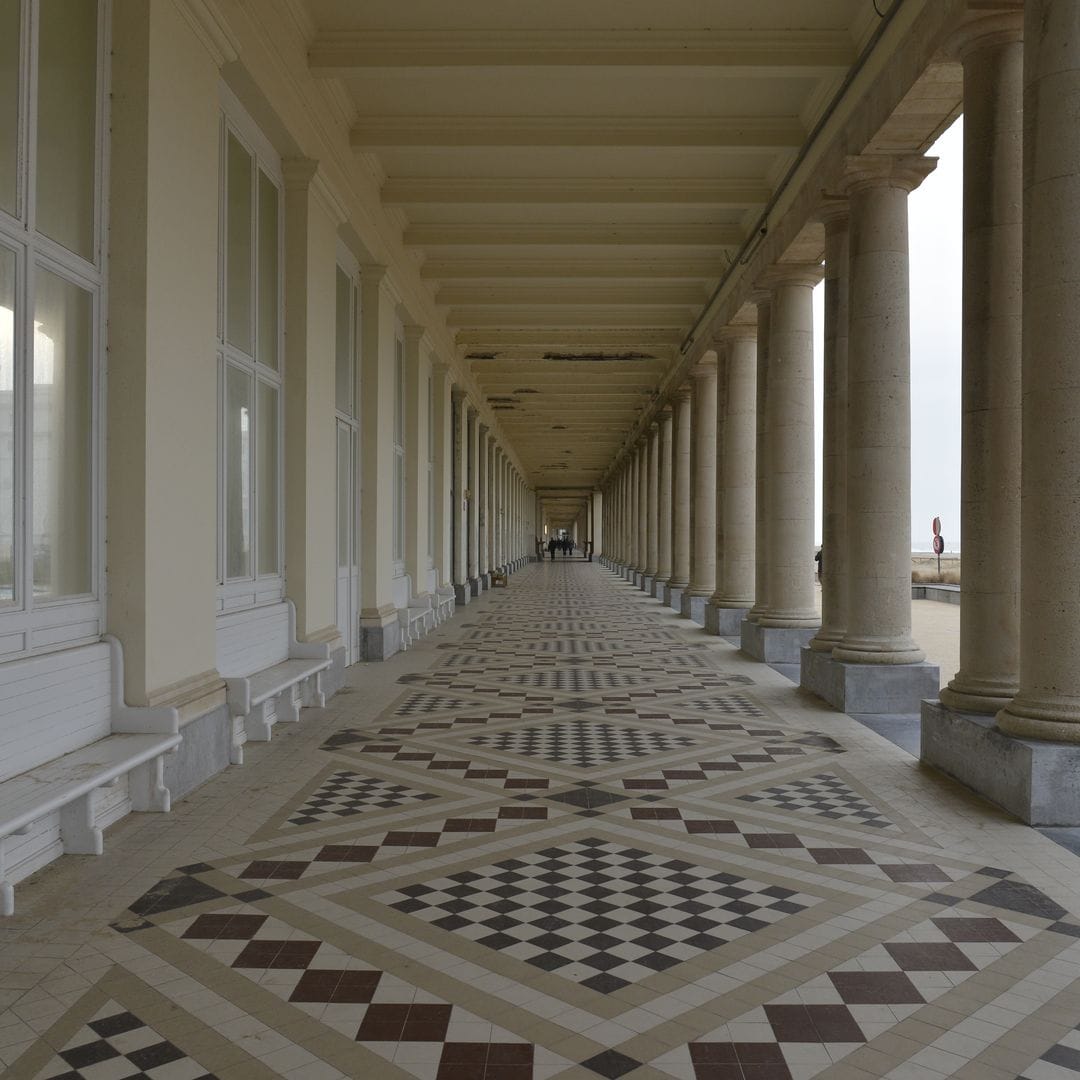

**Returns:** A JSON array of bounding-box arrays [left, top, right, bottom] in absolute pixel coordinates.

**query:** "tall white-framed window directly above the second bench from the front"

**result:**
[[218, 91, 282, 607]]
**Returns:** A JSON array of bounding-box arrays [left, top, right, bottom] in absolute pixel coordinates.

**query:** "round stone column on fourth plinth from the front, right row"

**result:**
[[705, 324, 757, 637]]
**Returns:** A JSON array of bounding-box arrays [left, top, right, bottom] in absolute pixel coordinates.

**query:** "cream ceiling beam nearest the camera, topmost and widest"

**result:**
[[308, 27, 855, 78]]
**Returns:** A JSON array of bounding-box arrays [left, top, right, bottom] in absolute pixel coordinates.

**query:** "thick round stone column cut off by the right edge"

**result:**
[[993, 0, 1080, 743]]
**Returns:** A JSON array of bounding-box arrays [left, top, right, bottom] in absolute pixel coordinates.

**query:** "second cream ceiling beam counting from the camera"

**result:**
[[349, 116, 807, 152]]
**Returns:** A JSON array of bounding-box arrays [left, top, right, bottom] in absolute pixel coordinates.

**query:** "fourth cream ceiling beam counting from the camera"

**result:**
[[405, 221, 744, 247]]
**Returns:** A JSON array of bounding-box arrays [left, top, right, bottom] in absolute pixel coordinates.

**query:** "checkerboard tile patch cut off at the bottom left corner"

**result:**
[[38, 1001, 216, 1080]]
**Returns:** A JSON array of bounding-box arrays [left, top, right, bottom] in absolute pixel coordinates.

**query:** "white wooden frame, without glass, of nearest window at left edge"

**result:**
[[0, 0, 112, 660]]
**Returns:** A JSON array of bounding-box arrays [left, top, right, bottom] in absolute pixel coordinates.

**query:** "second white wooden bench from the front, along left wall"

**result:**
[[211, 599, 330, 765]]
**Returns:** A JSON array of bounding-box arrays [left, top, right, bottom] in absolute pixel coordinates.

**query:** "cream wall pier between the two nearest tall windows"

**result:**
[[107, 0, 220, 705]]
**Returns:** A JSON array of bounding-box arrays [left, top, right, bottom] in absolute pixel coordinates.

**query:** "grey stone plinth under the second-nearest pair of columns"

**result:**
[[799, 647, 941, 715]]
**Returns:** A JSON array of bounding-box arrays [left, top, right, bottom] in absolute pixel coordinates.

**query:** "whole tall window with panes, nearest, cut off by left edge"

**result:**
[[0, 0, 107, 654]]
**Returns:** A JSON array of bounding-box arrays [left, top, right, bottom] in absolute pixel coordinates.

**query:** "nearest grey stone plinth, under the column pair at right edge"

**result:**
[[919, 700, 1080, 826]]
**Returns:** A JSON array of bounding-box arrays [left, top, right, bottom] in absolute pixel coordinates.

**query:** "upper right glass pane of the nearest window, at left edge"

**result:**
[[36, 0, 97, 259]]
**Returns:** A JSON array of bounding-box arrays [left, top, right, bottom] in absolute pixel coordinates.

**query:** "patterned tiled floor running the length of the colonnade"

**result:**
[[0, 561, 1080, 1080]]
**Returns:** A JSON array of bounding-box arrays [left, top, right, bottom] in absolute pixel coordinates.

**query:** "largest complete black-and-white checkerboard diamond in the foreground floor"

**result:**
[[379, 838, 819, 994]]
